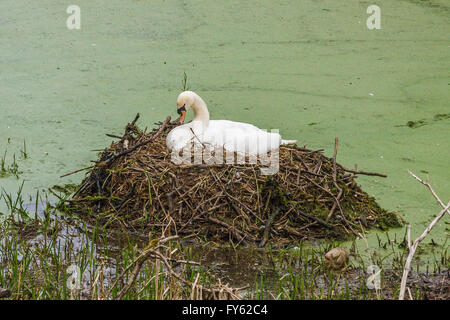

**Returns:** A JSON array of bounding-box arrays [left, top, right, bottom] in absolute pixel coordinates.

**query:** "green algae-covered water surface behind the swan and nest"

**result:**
[[0, 0, 450, 260]]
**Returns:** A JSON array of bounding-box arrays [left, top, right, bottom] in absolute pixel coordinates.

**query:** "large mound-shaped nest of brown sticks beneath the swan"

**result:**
[[68, 114, 400, 247]]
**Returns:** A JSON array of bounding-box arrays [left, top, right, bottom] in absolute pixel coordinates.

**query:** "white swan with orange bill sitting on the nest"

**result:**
[[166, 91, 296, 155]]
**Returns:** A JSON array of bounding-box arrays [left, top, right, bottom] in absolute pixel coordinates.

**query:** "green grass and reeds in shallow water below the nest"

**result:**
[[0, 184, 449, 300]]
